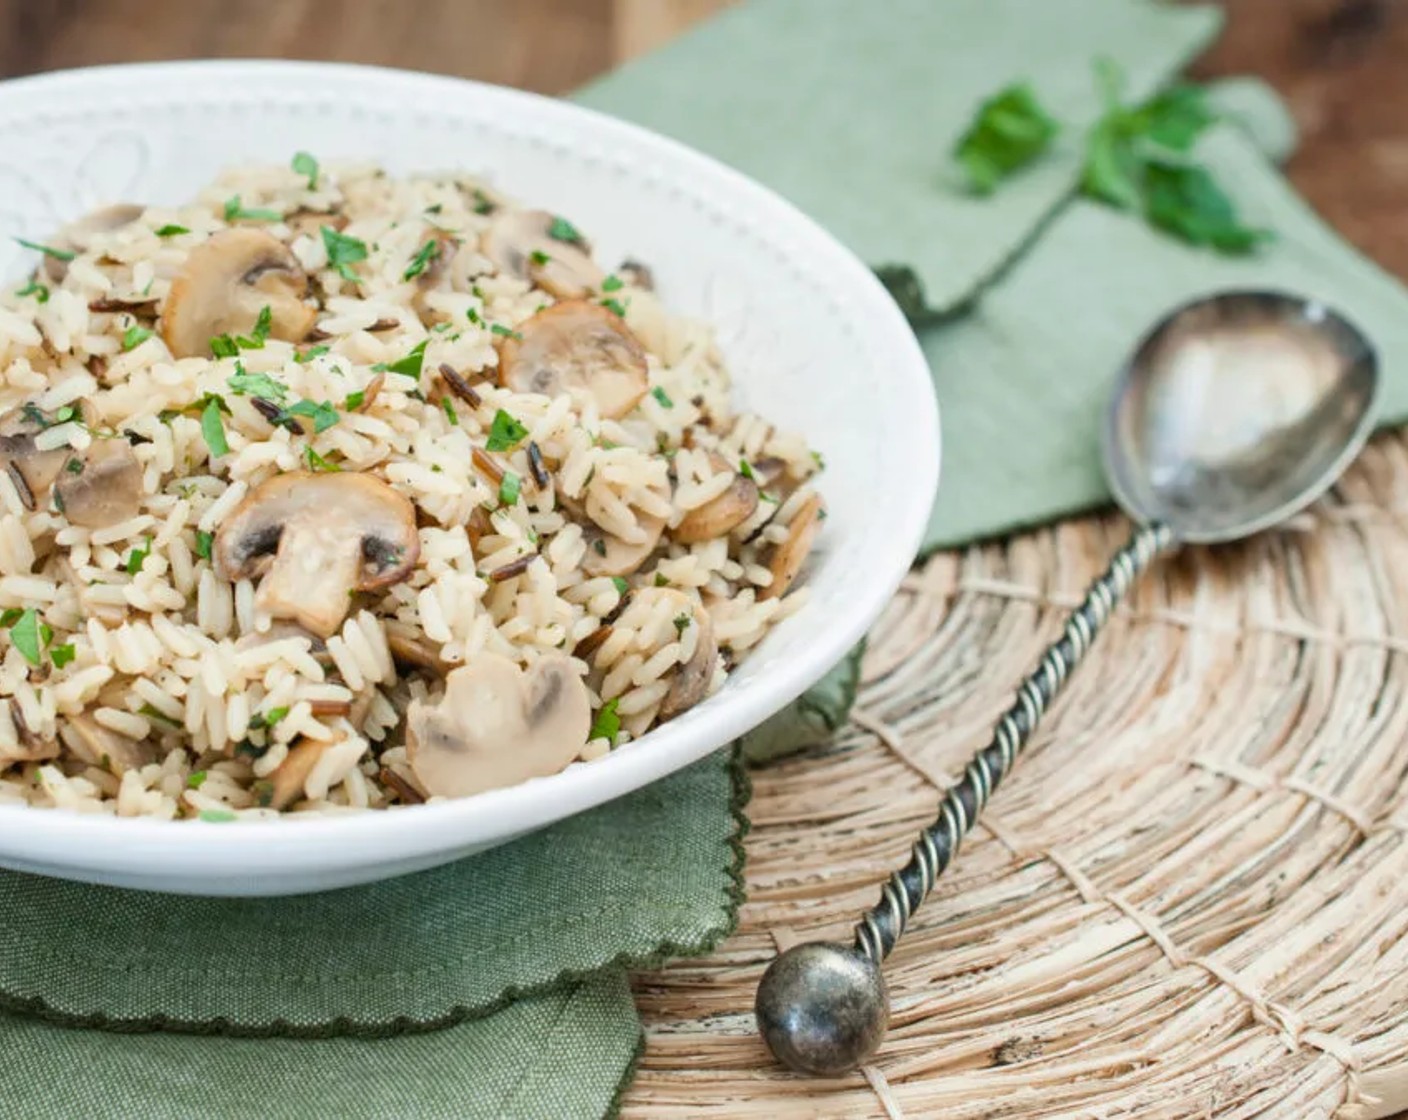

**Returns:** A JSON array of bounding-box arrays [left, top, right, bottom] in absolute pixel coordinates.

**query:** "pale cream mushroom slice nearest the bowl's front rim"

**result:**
[[406, 652, 591, 797]]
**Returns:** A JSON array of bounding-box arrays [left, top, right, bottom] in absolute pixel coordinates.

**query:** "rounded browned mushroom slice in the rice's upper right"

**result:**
[[498, 300, 650, 420]]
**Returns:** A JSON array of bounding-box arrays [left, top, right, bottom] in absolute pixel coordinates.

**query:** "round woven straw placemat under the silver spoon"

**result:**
[[624, 437, 1408, 1120]]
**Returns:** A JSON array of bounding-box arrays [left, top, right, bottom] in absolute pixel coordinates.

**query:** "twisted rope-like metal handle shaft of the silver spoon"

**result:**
[[856, 523, 1174, 965]]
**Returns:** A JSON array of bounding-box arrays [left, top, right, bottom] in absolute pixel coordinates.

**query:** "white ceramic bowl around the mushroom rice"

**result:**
[[0, 62, 939, 895]]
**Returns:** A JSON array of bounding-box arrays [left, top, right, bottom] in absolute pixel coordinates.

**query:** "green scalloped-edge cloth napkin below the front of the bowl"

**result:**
[[0, 752, 748, 1120]]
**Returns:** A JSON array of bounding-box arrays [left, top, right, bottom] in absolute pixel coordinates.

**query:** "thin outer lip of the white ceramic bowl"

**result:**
[[0, 61, 941, 895]]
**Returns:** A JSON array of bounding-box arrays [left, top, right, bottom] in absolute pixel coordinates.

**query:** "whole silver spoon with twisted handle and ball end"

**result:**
[[755, 292, 1378, 1075]]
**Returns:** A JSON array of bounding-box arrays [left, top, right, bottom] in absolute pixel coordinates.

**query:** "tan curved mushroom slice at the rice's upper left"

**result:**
[[161, 227, 318, 358]]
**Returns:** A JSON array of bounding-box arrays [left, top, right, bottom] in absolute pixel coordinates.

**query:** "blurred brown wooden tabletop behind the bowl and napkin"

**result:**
[[0, 0, 1408, 1115]]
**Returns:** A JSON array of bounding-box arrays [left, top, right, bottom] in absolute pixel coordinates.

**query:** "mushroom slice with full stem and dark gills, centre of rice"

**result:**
[[214, 471, 421, 638]]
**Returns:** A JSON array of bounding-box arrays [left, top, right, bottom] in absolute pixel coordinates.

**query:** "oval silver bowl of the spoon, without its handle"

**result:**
[[1102, 292, 1378, 544]]
